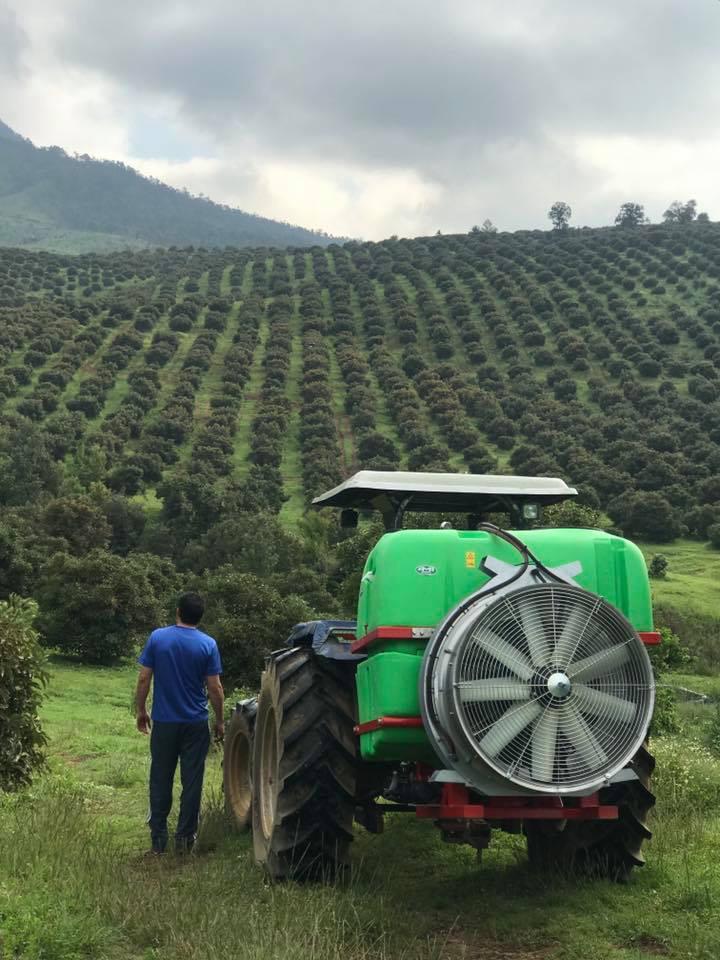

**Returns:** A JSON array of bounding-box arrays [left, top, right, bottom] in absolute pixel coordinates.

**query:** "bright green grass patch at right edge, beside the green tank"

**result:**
[[640, 540, 720, 616]]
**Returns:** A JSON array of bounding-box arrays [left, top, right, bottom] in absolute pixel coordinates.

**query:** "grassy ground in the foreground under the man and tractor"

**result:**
[[0, 662, 720, 960]]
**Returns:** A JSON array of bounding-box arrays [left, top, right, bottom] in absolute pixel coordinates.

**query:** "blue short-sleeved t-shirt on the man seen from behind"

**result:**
[[138, 627, 222, 723]]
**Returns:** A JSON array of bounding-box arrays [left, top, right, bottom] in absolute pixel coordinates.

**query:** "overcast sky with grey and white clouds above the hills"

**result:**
[[0, 0, 720, 239]]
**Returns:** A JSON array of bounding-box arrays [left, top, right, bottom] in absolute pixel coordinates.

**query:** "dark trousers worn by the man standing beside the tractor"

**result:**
[[148, 720, 210, 853]]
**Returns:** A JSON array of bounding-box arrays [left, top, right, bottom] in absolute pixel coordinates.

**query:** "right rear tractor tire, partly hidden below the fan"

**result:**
[[525, 746, 655, 883]]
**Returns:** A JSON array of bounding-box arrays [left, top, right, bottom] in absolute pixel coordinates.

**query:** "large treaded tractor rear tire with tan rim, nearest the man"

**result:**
[[252, 647, 357, 880]]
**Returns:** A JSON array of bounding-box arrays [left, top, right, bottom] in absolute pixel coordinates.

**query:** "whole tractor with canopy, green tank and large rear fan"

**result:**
[[224, 470, 660, 881]]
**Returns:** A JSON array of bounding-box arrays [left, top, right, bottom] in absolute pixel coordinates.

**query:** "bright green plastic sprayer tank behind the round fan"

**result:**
[[357, 529, 652, 762]]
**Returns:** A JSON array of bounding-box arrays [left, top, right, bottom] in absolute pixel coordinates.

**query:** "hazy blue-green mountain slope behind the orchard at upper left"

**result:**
[[0, 121, 330, 253]]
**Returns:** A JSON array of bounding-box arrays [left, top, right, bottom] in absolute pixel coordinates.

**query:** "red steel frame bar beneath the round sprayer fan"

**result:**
[[415, 783, 618, 821]]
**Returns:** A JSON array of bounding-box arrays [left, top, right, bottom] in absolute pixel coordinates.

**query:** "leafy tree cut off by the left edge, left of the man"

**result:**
[[0, 595, 46, 790]]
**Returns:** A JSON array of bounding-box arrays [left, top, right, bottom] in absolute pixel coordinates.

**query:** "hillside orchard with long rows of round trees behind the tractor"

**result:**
[[0, 224, 720, 544]]
